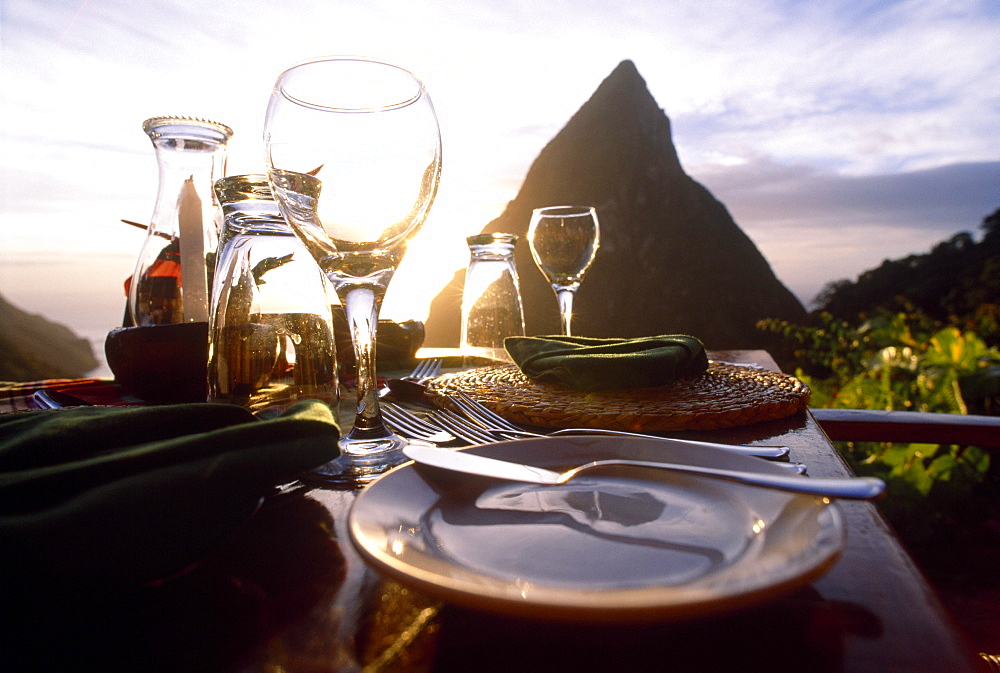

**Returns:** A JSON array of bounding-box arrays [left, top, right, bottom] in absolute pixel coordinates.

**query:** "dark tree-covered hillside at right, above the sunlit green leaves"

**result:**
[[816, 209, 1000, 345]]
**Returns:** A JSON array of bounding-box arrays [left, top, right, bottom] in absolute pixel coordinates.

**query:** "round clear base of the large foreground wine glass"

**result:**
[[303, 435, 428, 488]]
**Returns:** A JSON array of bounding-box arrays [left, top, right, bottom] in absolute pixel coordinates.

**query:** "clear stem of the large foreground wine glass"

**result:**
[[337, 285, 382, 439]]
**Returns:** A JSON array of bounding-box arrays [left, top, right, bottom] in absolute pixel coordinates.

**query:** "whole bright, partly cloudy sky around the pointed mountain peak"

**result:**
[[0, 0, 1000, 372]]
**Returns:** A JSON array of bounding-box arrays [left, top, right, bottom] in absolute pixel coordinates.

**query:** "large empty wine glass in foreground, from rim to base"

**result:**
[[264, 57, 441, 483]]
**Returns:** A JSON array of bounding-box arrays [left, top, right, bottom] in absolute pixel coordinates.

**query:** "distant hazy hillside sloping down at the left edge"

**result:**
[[0, 297, 99, 381]]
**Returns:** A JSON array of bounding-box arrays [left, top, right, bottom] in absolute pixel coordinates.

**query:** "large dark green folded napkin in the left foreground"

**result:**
[[0, 400, 340, 586]]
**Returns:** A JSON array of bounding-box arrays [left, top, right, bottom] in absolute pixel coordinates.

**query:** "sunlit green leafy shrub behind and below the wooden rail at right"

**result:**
[[761, 310, 1000, 546]]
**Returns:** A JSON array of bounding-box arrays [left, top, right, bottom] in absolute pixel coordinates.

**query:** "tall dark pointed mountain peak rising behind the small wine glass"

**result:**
[[426, 60, 806, 349]]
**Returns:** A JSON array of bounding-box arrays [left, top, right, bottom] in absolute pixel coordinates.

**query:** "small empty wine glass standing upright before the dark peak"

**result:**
[[528, 206, 601, 336]]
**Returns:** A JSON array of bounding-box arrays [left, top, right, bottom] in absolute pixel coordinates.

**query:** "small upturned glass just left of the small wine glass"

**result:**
[[461, 234, 524, 361]]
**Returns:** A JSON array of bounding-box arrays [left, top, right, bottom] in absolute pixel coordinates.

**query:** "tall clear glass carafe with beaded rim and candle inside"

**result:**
[[125, 117, 233, 325]]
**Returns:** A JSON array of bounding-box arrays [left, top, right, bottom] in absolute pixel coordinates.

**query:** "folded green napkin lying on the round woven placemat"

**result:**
[[504, 334, 708, 392]]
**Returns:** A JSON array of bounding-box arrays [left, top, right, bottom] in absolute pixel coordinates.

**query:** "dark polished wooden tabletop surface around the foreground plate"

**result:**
[[0, 351, 987, 673]]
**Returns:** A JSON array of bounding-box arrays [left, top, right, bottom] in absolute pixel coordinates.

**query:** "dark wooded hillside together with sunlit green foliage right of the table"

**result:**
[[760, 210, 1000, 600]]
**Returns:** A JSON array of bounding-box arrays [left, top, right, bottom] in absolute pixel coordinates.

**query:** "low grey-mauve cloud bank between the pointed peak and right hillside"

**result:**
[[689, 158, 1000, 305]]
